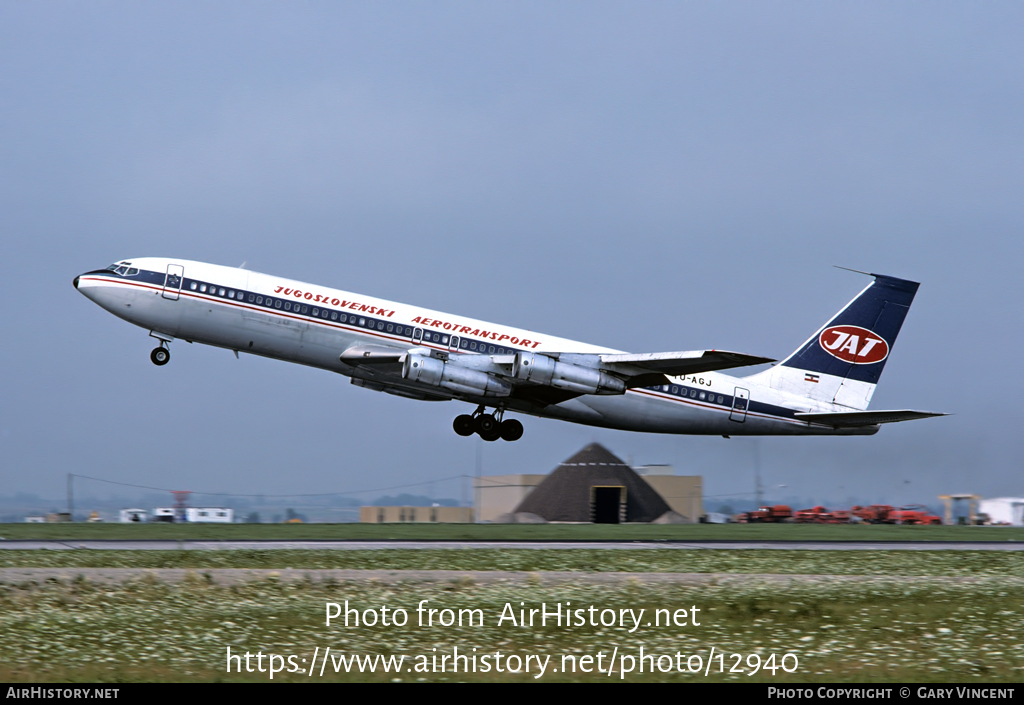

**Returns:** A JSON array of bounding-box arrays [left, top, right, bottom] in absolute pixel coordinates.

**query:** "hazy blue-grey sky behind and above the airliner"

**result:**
[[0, 1, 1024, 503]]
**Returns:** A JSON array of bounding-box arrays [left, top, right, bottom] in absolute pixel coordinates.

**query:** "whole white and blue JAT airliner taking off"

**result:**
[[75, 257, 942, 441]]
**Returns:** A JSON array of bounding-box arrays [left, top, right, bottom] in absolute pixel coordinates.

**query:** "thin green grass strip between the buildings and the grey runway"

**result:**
[[0, 524, 1024, 541]]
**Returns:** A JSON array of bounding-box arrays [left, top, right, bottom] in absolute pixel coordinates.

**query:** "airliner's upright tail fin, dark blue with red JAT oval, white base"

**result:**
[[754, 275, 920, 409]]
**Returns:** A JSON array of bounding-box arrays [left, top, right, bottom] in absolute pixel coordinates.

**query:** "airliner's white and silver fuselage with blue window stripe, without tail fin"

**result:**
[[76, 258, 879, 436]]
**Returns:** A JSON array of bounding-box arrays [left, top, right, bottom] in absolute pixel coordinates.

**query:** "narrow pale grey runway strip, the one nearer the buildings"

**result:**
[[0, 540, 1024, 551]]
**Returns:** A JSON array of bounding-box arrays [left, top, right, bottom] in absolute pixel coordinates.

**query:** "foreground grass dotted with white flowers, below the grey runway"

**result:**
[[0, 549, 1024, 685]]
